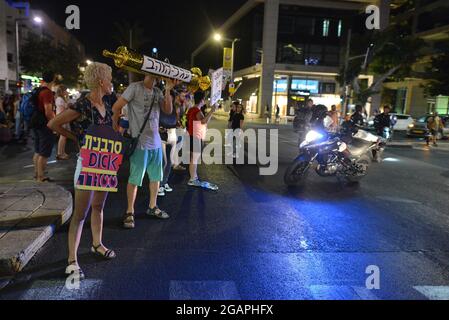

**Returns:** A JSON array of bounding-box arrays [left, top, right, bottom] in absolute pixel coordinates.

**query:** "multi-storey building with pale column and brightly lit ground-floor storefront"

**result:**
[[193, 0, 390, 116]]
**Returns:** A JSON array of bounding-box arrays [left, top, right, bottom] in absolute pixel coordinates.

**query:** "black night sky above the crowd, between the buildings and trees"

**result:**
[[30, 0, 246, 64]]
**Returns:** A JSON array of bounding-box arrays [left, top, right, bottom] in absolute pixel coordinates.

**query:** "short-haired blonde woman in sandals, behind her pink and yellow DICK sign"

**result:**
[[48, 62, 116, 279]]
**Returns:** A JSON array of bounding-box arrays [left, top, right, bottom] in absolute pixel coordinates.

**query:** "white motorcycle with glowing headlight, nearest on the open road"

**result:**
[[284, 130, 379, 187]]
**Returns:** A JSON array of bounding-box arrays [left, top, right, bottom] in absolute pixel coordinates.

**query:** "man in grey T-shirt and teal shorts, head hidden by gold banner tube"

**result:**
[[113, 75, 179, 229]]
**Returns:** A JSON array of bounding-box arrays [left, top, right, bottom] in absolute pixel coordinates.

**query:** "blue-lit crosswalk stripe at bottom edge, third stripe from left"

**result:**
[[309, 285, 379, 300]]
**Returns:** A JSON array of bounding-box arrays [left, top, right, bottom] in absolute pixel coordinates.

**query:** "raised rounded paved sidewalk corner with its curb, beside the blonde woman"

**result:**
[[0, 183, 72, 286]]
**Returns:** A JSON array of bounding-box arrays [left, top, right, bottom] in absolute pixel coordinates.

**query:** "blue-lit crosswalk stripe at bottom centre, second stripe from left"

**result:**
[[169, 281, 241, 300]]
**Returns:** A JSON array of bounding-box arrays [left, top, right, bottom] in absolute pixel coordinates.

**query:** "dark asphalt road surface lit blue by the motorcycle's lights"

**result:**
[[0, 121, 449, 300]]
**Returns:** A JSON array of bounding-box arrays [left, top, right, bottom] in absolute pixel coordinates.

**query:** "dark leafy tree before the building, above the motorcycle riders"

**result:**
[[339, 21, 423, 105]]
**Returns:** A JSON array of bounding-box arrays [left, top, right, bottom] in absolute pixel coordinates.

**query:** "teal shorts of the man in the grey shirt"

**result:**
[[128, 148, 164, 187]]
